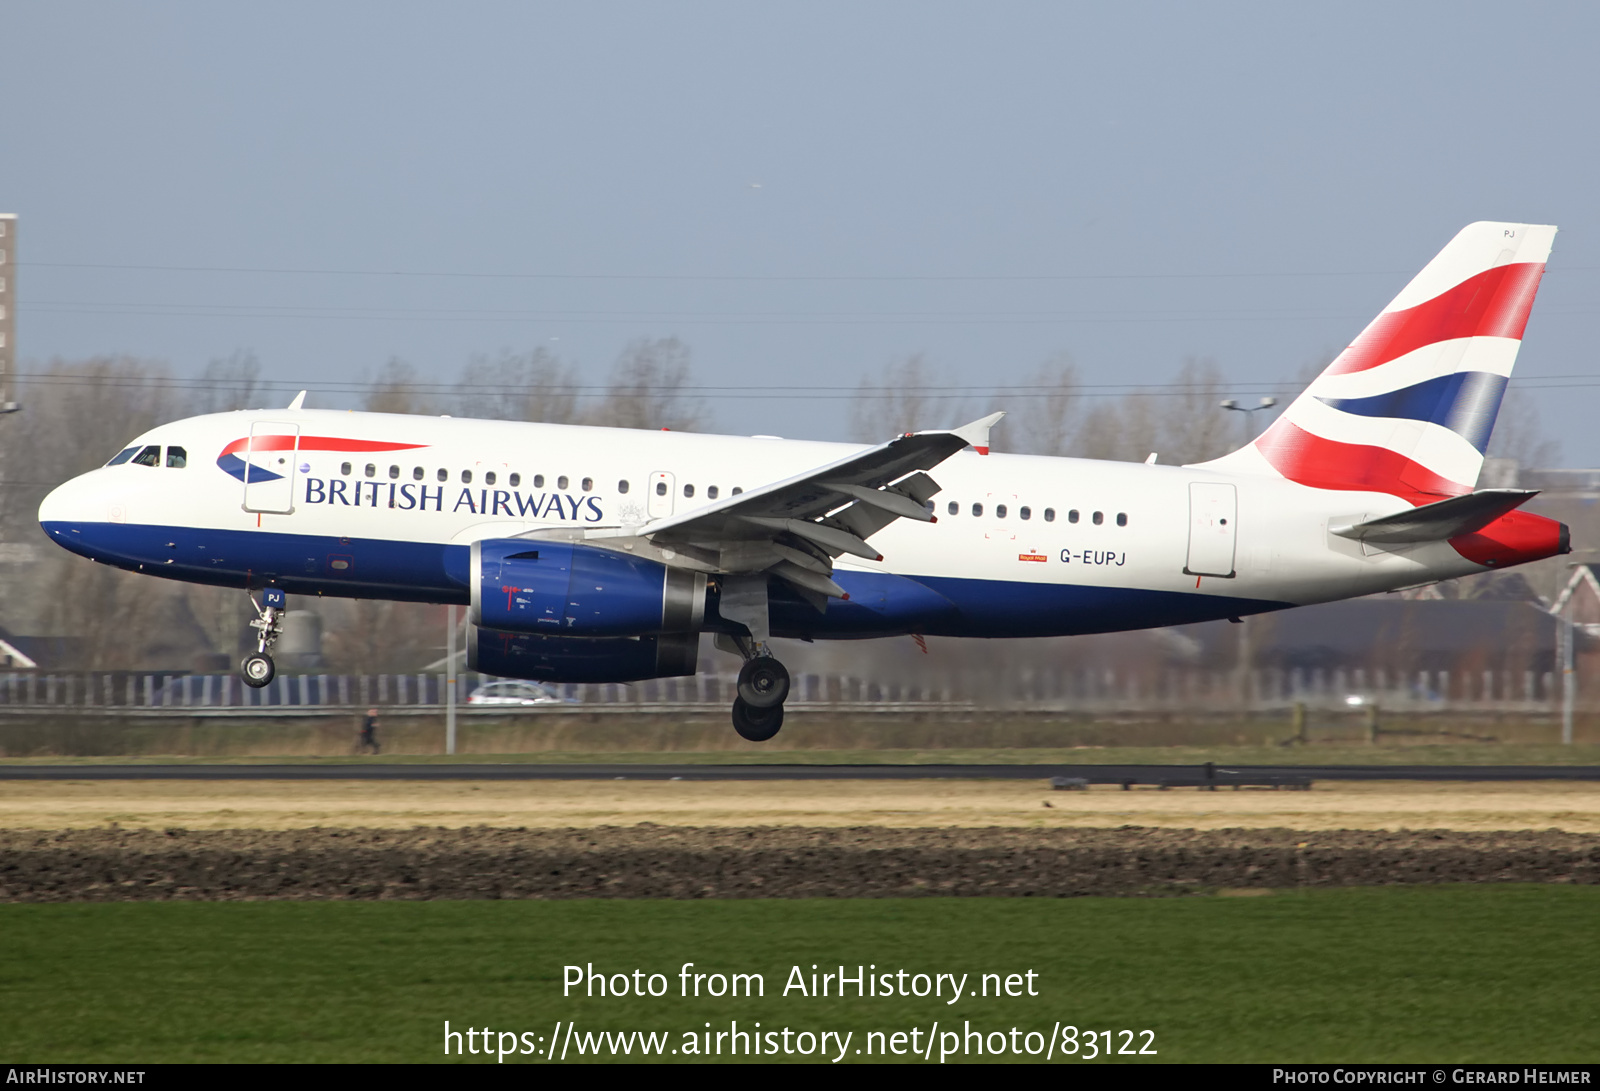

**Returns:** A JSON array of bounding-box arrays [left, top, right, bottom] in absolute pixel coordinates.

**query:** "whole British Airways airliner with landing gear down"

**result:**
[[38, 222, 1570, 741]]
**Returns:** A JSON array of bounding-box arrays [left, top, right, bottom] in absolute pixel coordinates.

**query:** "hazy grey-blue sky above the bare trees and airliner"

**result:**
[[0, 0, 1600, 466]]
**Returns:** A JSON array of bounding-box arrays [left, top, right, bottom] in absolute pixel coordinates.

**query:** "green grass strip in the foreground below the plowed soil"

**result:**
[[0, 886, 1600, 1062]]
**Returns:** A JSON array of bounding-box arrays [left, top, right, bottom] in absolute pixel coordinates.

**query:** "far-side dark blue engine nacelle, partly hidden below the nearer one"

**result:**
[[467, 625, 699, 681]]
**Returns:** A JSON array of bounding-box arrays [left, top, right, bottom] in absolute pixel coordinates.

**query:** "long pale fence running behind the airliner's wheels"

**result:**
[[0, 669, 1580, 715]]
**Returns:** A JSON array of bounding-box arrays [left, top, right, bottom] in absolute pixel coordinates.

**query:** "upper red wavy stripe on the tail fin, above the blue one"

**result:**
[[1323, 262, 1544, 374]]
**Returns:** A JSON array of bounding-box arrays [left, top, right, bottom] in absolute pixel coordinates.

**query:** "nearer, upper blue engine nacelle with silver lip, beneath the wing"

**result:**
[[472, 538, 706, 633]]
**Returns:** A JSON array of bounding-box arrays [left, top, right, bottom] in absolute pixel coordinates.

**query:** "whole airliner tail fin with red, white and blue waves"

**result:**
[[1208, 222, 1555, 504]]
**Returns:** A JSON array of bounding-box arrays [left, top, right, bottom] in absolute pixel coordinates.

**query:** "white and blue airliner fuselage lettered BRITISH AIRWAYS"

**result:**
[[40, 410, 1510, 637]]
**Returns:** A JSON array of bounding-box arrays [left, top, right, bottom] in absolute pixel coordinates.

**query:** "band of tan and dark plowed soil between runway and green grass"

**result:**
[[0, 781, 1600, 902]]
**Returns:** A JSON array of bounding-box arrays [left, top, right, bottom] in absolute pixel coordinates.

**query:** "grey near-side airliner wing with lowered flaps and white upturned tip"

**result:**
[[640, 413, 1005, 606]]
